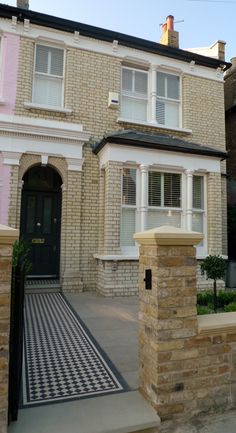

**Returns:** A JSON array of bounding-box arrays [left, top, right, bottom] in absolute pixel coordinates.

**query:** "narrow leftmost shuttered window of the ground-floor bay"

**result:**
[[120, 168, 136, 247]]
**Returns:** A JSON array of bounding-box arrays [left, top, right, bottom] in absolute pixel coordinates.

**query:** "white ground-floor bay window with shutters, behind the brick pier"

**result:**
[[120, 165, 206, 255]]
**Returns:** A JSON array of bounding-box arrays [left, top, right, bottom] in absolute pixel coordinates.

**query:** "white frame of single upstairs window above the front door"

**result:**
[[32, 41, 66, 111]]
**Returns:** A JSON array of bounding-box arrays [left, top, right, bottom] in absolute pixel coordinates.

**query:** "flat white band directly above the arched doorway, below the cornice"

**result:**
[[0, 135, 83, 159]]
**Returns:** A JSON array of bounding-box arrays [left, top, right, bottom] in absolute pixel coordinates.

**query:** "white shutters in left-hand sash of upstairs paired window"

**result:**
[[121, 68, 147, 121]]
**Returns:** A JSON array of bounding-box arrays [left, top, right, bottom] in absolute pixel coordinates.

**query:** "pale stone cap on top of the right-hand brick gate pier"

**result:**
[[133, 226, 203, 246]]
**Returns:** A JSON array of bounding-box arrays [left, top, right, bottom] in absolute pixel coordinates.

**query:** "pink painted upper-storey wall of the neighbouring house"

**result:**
[[0, 33, 20, 114]]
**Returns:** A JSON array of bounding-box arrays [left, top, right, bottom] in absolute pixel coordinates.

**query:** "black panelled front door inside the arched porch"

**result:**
[[21, 167, 61, 278]]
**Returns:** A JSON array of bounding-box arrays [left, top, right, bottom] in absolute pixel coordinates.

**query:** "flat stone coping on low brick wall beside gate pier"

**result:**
[[198, 312, 236, 335]]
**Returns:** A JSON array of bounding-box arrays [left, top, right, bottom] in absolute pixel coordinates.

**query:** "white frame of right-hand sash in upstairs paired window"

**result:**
[[155, 68, 182, 129]]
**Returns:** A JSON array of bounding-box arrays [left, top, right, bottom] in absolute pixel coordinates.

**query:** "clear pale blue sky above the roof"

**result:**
[[2, 0, 236, 61]]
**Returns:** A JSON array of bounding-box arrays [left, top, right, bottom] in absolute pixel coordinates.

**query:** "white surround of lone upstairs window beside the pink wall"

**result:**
[[31, 42, 66, 110]]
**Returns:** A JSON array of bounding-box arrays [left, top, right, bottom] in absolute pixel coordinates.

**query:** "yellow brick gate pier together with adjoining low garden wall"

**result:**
[[135, 227, 236, 420]]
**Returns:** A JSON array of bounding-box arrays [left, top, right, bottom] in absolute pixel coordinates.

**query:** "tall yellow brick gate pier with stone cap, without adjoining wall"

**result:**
[[134, 226, 202, 419]]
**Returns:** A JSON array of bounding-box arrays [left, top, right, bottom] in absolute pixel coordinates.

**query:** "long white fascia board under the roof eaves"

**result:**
[[0, 19, 224, 82]]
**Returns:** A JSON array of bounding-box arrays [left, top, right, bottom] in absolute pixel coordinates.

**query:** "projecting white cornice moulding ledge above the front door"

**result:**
[[0, 115, 91, 143]]
